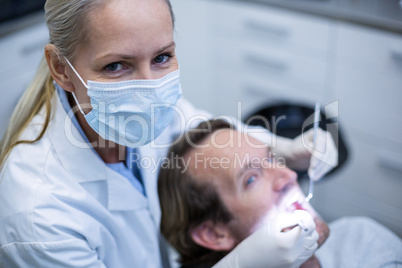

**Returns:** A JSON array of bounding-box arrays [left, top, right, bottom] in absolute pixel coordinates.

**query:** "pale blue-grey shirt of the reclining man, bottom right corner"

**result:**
[[315, 217, 402, 268]]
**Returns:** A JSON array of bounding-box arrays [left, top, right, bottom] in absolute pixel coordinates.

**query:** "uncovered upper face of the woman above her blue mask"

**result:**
[[70, 0, 178, 109]]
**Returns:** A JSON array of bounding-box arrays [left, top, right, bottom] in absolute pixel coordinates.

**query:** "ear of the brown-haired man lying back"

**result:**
[[191, 221, 236, 251]]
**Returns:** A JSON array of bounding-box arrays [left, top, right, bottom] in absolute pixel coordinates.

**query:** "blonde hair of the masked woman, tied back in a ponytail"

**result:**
[[0, 0, 174, 170]]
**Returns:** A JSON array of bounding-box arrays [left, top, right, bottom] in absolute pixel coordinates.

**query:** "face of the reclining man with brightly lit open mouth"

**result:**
[[187, 129, 306, 242]]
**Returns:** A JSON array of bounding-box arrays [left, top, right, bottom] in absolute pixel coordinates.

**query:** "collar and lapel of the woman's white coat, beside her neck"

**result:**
[[49, 90, 148, 210]]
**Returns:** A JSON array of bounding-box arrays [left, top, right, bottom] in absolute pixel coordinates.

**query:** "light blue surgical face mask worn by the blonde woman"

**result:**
[[66, 59, 182, 147]]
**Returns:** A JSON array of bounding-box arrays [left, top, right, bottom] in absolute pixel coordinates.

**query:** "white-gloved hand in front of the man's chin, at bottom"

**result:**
[[213, 210, 318, 268]]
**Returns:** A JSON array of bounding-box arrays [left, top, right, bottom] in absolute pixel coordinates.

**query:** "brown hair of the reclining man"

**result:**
[[158, 119, 234, 266]]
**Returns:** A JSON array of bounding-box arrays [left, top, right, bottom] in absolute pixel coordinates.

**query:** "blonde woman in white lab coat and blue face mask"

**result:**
[[0, 0, 336, 267]]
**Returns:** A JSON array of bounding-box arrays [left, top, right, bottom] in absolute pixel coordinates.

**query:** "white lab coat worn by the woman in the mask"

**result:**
[[0, 91, 214, 268]]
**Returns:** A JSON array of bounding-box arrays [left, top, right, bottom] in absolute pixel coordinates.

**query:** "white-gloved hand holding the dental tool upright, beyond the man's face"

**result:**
[[271, 128, 338, 181]]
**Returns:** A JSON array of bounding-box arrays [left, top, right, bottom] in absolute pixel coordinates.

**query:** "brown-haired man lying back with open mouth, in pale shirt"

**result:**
[[158, 120, 402, 267]]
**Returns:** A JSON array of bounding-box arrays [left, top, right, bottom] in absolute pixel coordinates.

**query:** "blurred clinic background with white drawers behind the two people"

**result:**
[[0, 0, 402, 237]]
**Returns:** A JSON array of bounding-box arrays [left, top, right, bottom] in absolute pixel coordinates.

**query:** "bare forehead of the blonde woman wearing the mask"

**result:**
[[80, 0, 173, 56]]
